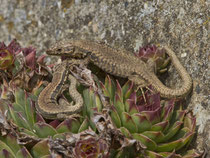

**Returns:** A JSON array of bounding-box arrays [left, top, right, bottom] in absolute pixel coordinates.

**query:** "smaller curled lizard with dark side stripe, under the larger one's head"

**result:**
[[36, 61, 83, 119]]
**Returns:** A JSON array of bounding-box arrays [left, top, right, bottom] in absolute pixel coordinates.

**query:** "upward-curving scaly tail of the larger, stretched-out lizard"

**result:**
[[148, 46, 192, 98]]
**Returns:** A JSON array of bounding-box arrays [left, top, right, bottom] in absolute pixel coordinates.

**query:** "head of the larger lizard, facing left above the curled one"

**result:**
[[46, 41, 88, 59]]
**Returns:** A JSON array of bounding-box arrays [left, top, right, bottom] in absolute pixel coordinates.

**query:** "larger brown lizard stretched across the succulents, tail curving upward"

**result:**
[[47, 40, 192, 98]]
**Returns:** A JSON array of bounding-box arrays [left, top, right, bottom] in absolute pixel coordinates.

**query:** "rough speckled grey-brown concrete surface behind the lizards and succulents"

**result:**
[[0, 0, 210, 157]]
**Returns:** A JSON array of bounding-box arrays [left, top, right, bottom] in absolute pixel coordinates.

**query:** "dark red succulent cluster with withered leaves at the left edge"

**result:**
[[0, 39, 51, 100]]
